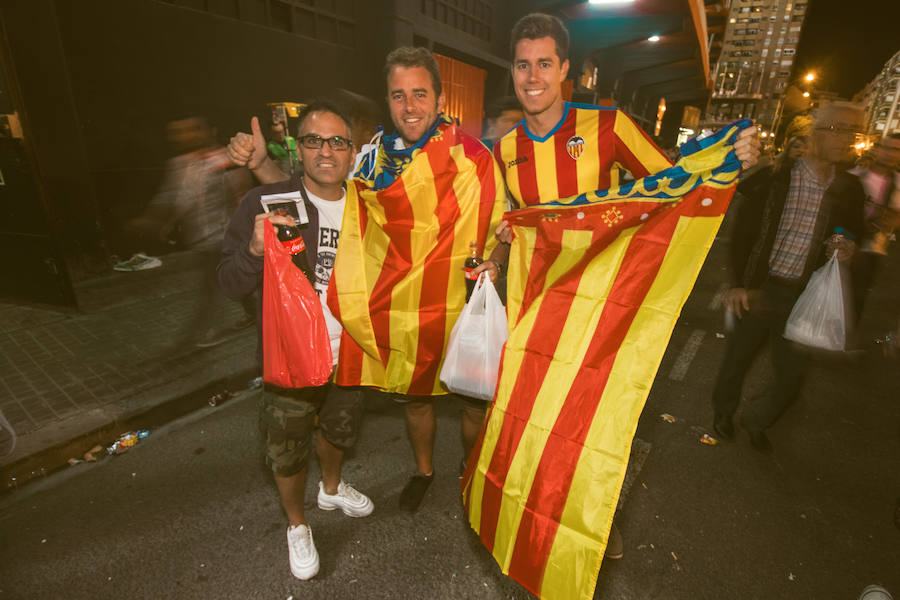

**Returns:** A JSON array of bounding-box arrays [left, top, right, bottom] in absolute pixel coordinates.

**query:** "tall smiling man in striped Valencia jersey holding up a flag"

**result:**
[[474, 13, 759, 558]]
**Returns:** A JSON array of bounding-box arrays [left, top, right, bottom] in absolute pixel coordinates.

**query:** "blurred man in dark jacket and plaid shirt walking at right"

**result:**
[[712, 103, 864, 453]]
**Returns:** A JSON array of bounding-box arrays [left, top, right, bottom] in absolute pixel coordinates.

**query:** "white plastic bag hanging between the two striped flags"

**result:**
[[441, 273, 509, 400]]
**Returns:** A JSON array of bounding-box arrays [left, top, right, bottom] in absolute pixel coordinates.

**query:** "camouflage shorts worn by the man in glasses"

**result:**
[[259, 383, 363, 477]]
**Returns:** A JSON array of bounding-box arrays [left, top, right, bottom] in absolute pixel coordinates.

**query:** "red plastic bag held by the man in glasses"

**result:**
[[262, 221, 332, 388]]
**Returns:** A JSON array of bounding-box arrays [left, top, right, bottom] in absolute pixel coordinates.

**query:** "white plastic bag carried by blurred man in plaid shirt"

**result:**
[[784, 251, 850, 350]]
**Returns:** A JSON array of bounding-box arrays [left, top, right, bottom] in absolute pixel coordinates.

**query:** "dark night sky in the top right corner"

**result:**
[[794, 0, 900, 99]]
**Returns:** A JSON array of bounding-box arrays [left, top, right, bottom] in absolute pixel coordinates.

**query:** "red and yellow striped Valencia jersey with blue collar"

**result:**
[[494, 102, 672, 206]]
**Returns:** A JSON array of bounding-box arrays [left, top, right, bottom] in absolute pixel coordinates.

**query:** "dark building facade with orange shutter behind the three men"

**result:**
[[0, 0, 705, 306]]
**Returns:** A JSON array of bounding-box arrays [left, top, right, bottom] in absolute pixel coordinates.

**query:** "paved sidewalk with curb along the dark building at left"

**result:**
[[0, 251, 256, 480]]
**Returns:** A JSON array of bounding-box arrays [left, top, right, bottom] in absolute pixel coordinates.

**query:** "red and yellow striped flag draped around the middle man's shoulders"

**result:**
[[329, 120, 507, 396]]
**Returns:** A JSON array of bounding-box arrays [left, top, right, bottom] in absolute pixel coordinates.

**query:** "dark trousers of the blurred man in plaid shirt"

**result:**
[[713, 281, 809, 431]]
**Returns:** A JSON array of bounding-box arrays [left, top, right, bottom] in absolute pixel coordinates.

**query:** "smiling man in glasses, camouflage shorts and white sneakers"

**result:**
[[218, 101, 374, 579]]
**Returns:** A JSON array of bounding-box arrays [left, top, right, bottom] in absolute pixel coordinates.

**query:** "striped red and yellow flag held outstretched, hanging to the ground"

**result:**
[[462, 122, 748, 599]]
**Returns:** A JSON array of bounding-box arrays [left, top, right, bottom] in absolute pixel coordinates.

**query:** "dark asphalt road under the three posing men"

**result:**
[[0, 233, 900, 600]]
